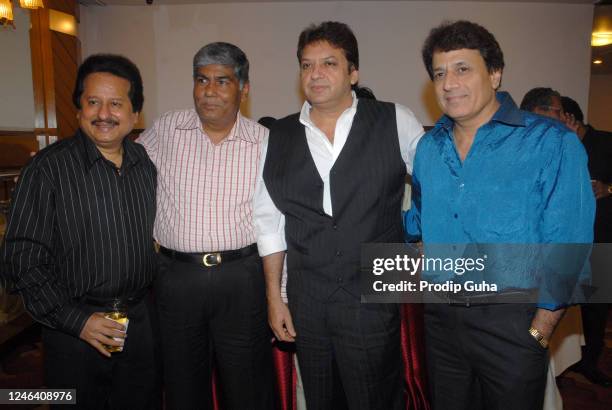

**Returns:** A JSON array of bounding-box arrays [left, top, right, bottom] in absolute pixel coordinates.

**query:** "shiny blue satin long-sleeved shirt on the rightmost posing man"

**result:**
[[404, 92, 595, 309]]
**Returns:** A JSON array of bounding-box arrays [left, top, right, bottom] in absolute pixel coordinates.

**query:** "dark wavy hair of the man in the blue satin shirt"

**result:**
[[421, 20, 504, 80]]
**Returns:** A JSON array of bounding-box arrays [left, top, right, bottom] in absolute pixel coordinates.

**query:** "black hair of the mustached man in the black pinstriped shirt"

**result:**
[[72, 54, 144, 112]]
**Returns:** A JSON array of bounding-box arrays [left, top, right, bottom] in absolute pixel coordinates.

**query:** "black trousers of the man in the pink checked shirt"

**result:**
[[155, 254, 275, 410]]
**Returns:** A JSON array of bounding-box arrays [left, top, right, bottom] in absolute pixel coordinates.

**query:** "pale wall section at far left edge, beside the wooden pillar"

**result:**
[[0, 6, 34, 130]]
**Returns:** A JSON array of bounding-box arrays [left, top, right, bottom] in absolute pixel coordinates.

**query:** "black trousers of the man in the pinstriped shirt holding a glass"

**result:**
[[42, 298, 161, 410]]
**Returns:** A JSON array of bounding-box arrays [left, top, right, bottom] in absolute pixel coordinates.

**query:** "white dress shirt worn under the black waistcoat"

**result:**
[[253, 92, 424, 256]]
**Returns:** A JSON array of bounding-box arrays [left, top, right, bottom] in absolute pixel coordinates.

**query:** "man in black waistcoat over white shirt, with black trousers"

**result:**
[[254, 22, 423, 410]]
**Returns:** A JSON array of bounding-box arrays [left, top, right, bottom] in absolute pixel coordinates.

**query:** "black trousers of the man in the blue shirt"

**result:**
[[425, 304, 548, 410]]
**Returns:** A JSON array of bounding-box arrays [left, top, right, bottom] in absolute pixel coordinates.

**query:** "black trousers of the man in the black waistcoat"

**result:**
[[289, 289, 405, 410]]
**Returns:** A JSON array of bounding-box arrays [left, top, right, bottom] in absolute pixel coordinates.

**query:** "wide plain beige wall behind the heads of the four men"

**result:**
[[80, 1, 593, 125]]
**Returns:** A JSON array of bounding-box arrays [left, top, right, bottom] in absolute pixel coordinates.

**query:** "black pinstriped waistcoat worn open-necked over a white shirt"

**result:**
[[263, 99, 406, 299]]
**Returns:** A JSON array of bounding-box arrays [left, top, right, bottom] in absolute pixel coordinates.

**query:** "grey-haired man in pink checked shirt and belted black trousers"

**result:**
[[138, 43, 274, 410]]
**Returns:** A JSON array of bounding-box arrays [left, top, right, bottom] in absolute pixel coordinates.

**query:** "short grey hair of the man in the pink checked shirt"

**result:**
[[193, 41, 249, 90]]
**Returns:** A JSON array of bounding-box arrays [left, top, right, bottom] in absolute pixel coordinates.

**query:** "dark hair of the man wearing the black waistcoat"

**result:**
[[297, 21, 359, 71]]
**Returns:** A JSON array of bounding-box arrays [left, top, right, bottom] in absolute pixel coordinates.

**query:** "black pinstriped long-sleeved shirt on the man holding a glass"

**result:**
[[0, 131, 156, 336]]
